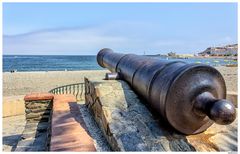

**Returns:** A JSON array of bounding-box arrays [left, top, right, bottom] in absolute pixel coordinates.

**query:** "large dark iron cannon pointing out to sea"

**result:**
[[97, 48, 236, 135]]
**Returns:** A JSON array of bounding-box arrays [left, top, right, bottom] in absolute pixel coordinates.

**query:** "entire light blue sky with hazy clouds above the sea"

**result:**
[[3, 3, 237, 55]]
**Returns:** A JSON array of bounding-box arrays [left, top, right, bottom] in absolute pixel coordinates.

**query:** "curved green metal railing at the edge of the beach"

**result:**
[[49, 83, 85, 101]]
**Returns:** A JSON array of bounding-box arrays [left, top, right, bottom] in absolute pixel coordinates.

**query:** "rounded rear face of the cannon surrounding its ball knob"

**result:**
[[164, 64, 226, 134]]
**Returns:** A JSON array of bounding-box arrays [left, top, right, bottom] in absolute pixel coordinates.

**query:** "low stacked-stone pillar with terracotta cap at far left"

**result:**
[[15, 93, 54, 151]]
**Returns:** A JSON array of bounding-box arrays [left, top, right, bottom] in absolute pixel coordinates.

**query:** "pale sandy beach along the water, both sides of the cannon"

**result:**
[[3, 66, 237, 96]]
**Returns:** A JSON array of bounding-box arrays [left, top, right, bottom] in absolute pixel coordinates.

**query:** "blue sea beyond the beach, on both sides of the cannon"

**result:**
[[3, 55, 237, 72]]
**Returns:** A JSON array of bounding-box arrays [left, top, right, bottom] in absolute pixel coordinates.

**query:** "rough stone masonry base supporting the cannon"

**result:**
[[85, 79, 237, 151]]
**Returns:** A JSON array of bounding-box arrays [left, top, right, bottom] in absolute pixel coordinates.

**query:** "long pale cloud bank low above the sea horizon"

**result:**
[[3, 21, 236, 55]]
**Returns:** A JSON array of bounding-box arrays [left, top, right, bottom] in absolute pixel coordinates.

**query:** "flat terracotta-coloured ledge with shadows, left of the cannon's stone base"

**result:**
[[50, 95, 96, 152]]
